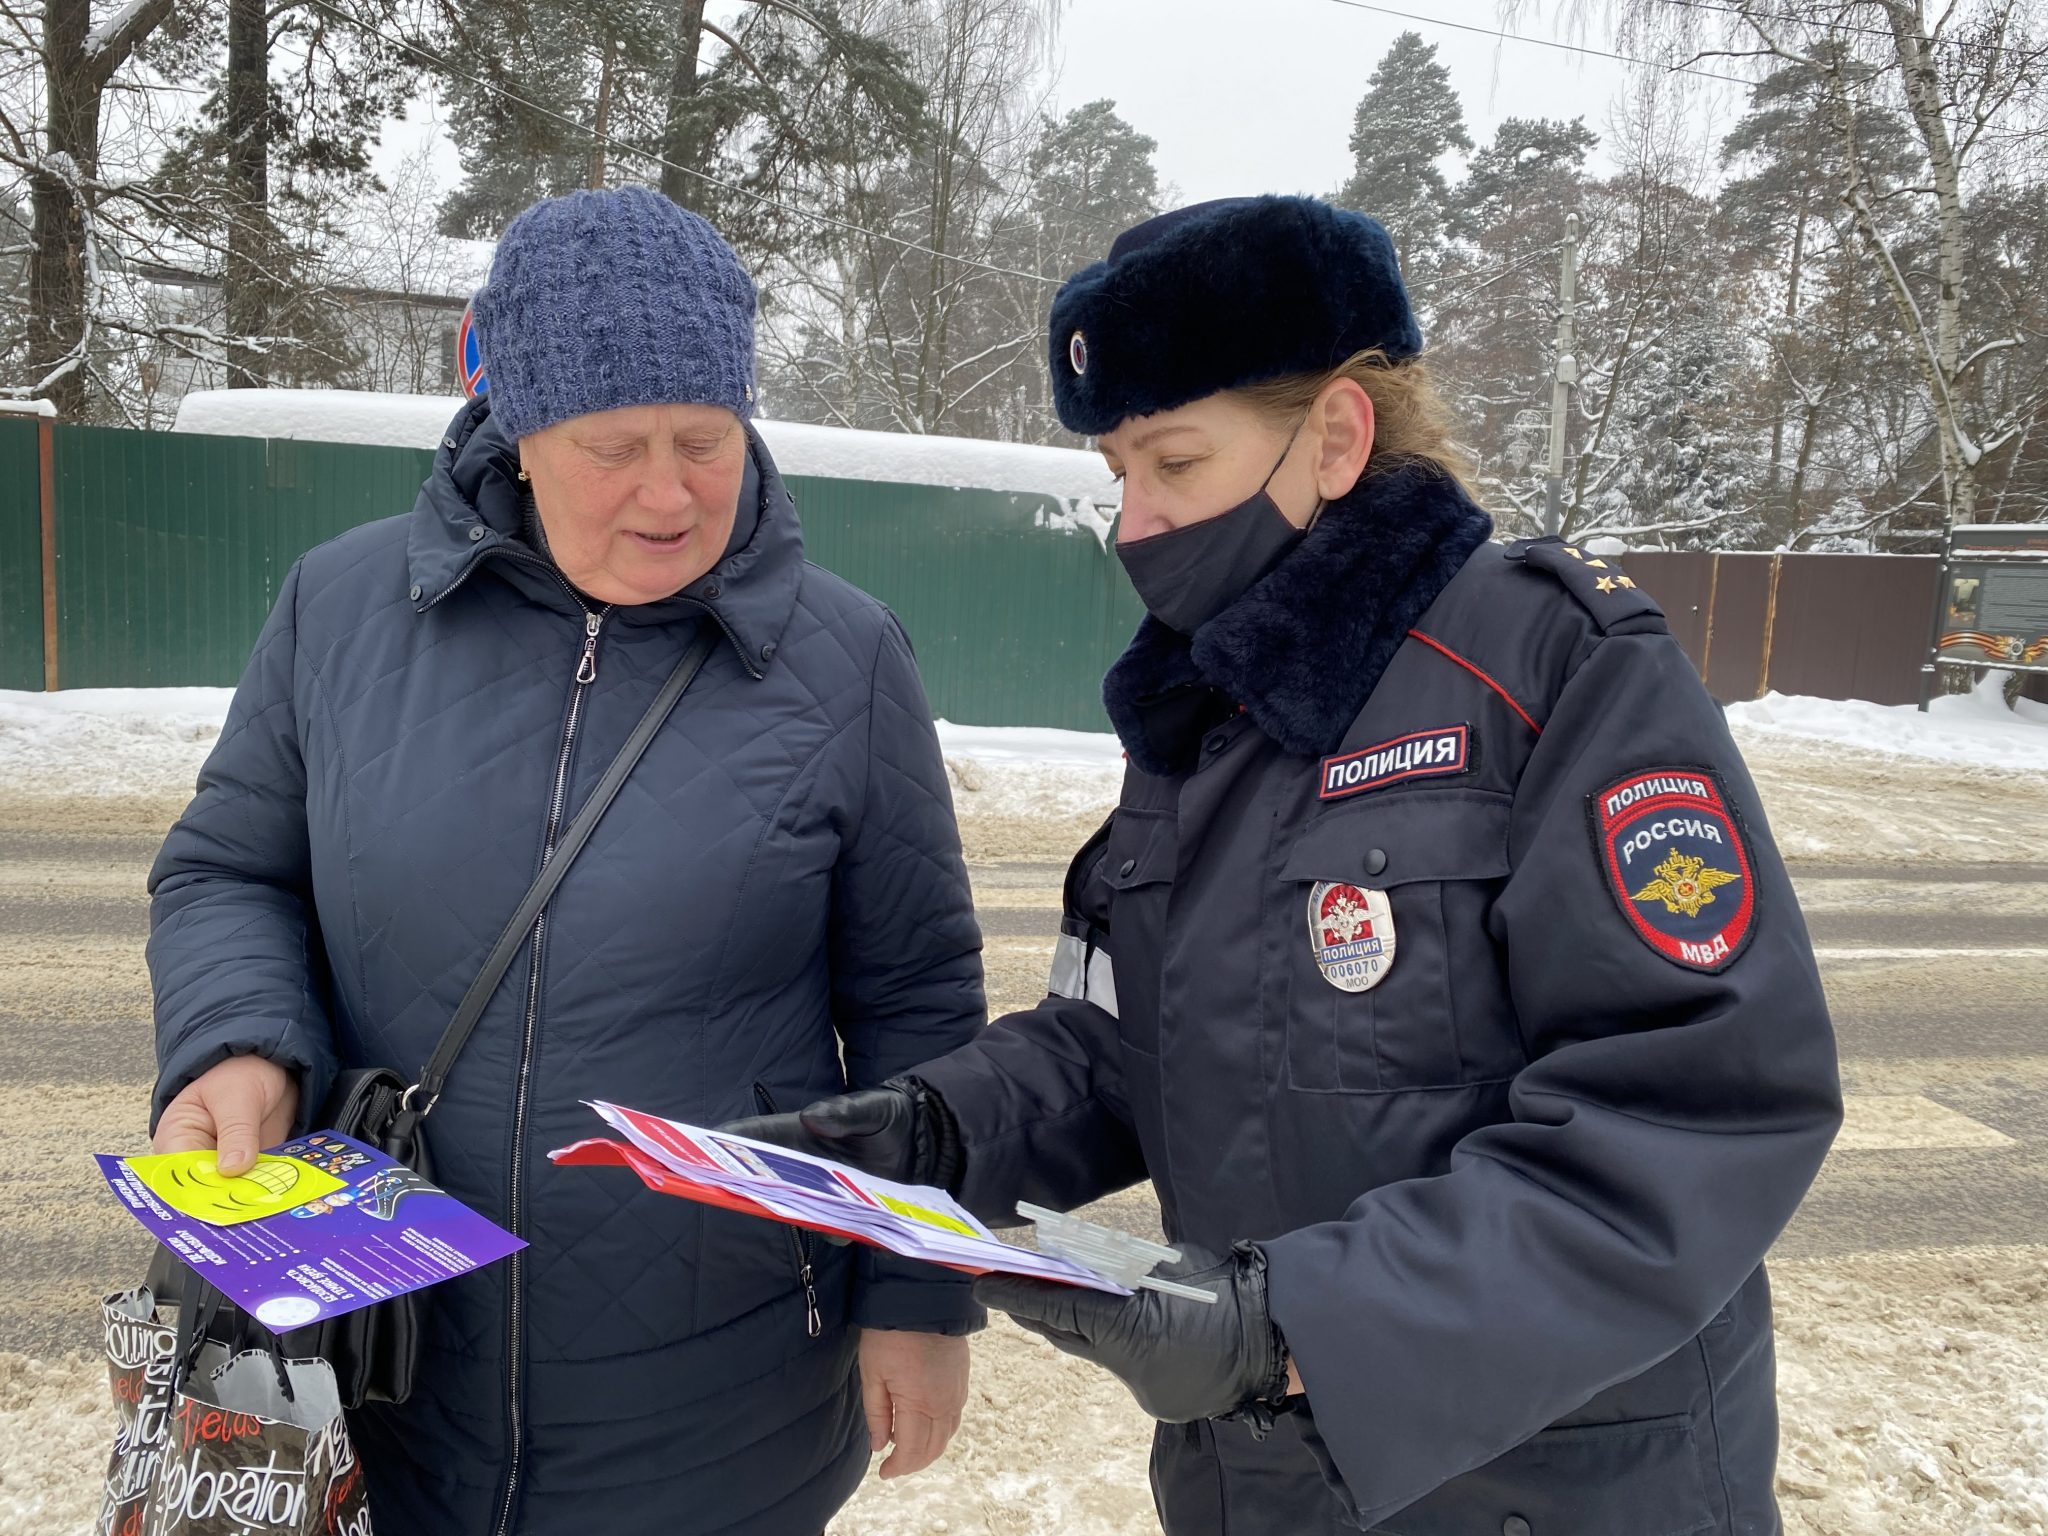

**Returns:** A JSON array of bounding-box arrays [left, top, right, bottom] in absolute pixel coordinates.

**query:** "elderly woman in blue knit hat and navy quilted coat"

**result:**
[[150, 190, 983, 1536]]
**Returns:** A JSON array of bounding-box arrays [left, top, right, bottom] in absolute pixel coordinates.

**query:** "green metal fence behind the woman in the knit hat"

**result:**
[[0, 420, 1141, 731]]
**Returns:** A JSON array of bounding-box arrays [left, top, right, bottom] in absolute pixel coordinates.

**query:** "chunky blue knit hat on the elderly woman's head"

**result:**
[[471, 186, 754, 438]]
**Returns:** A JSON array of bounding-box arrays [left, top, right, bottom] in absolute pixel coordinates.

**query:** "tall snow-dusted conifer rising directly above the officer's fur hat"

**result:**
[[1335, 33, 1473, 279]]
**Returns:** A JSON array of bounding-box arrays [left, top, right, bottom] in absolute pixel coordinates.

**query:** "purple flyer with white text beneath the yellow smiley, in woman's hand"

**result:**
[[94, 1130, 526, 1333]]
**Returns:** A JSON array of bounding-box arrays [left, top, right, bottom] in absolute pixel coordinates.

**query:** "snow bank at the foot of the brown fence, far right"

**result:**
[[1729, 672, 2048, 772]]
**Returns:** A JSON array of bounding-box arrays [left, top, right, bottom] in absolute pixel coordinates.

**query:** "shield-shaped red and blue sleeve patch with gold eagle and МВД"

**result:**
[[1591, 768, 1757, 971]]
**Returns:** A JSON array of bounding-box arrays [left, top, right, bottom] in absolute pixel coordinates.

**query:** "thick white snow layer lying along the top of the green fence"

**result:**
[[170, 389, 1120, 541]]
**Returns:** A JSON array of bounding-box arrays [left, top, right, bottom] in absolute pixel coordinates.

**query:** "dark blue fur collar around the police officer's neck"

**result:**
[[1102, 465, 1493, 776]]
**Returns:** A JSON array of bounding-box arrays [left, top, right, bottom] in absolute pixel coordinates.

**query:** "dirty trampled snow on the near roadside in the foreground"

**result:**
[[0, 1247, 2048, 1536]]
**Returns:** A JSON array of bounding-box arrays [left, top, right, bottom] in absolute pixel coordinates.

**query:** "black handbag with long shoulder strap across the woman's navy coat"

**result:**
[[285, 623, 717, 1407]]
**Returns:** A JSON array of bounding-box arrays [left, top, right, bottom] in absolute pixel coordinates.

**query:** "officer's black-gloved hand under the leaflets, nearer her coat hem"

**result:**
[[975, 1243, 1286, 1438]]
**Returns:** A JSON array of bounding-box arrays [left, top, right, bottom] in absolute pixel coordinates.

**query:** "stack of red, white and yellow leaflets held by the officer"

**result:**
[[549, 1100, 1130, 1296]]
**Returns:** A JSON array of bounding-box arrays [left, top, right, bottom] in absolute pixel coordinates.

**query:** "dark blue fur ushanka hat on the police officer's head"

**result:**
[[1047, 197, 1421, 436]]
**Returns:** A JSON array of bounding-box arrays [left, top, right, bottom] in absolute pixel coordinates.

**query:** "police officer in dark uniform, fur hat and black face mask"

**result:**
[[741, 197, 1841, 1536]]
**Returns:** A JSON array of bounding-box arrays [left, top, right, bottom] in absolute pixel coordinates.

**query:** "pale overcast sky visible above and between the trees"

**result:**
[[377, 0, 1726, 221]]
